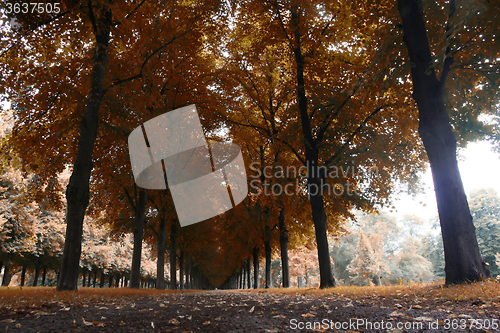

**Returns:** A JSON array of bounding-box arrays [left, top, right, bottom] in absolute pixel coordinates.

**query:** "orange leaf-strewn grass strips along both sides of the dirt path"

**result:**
[[0, 280, 500, 310]]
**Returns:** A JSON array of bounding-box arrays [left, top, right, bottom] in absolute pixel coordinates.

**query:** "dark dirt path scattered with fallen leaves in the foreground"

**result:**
[[0, 290, 500, 333]]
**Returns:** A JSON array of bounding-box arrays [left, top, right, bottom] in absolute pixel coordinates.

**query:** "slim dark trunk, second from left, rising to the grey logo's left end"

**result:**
[[130, 189, 147, 289]]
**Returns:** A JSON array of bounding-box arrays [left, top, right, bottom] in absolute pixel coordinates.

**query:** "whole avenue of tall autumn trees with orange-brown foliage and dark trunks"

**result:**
[[0, 0, 500, 290]]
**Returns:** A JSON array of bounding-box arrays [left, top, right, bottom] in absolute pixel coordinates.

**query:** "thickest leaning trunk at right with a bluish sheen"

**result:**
[[398, 0, 490, 284]]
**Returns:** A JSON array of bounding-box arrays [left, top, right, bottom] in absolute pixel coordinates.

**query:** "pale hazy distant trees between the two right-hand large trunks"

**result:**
[[330, 214, 444, 285]]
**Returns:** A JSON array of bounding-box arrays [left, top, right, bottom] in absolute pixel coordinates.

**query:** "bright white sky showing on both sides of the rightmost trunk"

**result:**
[[392, 141, 500, 219]]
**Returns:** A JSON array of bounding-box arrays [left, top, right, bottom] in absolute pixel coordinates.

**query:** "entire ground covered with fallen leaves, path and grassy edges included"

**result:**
[[0, 281, 500, 332]]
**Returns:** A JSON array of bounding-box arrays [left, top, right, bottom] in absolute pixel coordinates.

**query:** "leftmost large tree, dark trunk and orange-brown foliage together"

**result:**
[[1, 1, 225, 290]]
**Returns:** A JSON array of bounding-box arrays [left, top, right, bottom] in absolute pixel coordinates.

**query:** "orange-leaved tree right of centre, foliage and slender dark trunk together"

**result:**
[[217, 1, 422, 288]]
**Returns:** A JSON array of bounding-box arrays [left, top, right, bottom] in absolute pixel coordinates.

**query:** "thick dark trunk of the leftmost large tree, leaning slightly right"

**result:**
[[57, 3, 112, 291]]
